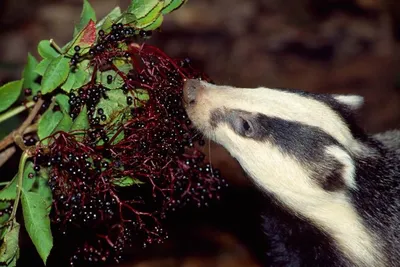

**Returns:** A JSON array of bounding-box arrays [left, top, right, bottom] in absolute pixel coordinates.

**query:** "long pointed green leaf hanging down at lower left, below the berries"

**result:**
[[21, 190, 53, 264]]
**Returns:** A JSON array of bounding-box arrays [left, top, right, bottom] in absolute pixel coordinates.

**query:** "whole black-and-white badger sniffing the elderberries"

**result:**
[[183, 79, 400, 267]]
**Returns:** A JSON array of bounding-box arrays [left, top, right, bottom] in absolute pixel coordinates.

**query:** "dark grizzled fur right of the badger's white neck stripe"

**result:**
[[350, 139, 400, 266]]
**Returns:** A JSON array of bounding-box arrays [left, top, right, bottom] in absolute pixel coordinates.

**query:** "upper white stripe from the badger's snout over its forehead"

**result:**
[[188, 81, 362, 156]]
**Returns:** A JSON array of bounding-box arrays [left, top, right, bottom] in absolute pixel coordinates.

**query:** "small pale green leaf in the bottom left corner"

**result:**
[[0, 222, 20, 266]]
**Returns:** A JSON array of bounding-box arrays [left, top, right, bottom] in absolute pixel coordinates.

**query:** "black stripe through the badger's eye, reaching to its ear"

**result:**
[[210, 109, 346, 191]]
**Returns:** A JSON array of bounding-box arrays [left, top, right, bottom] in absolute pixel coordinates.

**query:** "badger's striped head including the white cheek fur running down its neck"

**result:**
[[184, 80, 377, 265]]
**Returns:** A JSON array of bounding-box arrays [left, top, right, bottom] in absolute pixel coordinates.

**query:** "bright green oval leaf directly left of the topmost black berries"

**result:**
[[42, 56, 70, 94]]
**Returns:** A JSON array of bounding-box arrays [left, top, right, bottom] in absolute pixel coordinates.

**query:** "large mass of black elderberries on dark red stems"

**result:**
[[29, 24, 227, 265]]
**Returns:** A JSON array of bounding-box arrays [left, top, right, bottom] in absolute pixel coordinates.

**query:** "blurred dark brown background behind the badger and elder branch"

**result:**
[[0, 0, 400, 267]]
